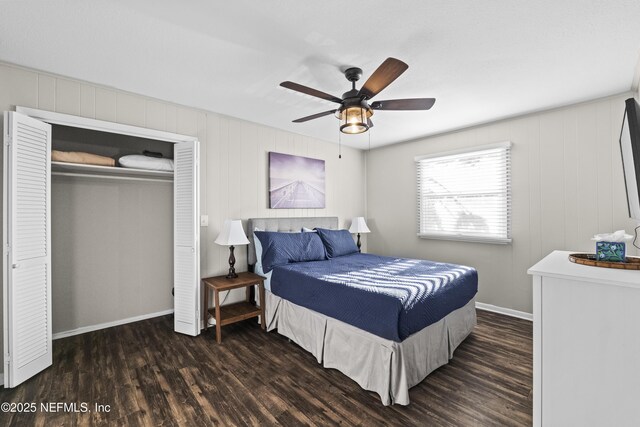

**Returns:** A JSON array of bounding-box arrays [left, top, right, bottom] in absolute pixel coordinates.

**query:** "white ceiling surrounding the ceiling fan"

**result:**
[[0, 0, 640, 148]]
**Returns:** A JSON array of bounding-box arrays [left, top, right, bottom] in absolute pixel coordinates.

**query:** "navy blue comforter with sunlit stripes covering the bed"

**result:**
[[271, 253, 478, 341]]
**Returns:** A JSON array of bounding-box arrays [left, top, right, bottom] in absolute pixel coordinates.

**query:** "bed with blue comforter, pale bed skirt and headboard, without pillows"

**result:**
[[247, 217, 477, 405]]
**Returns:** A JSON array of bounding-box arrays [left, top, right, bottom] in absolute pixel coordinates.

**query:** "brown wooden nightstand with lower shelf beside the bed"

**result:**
[[202, 272, 266, 344]]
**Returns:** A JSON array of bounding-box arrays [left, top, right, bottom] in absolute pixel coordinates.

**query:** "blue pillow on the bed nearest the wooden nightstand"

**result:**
[[255, 231, 327, 273]]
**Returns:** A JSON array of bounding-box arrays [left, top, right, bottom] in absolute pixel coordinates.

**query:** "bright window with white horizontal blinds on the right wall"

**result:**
[[415, 142, 511, 243]]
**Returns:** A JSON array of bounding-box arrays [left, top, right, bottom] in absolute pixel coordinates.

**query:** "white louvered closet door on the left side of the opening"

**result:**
[[3, 112, 52, 387]]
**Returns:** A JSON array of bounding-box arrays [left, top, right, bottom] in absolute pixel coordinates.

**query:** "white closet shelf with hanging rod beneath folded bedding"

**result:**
[[51, 162, 173, 181]]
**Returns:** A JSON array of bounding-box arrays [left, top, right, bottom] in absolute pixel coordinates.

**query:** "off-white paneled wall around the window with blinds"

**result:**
[[367, 93, 637, 313]]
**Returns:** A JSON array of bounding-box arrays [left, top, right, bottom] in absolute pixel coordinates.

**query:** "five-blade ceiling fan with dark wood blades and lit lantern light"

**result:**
[[280, 58, 436, 134]]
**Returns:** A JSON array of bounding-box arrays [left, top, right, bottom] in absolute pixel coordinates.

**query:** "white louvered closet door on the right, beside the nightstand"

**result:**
[[173, 141, 200, 336]]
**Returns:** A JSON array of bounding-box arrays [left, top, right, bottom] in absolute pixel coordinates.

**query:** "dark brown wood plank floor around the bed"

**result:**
[[0, 311, 532, 426]]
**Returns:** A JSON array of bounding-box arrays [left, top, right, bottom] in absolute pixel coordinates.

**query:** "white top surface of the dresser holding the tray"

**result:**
[[527, 251, 640, 289]]
